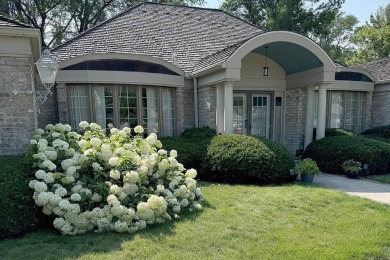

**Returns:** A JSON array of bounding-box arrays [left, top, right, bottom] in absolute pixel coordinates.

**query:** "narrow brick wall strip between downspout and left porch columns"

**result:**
[[198, 86, 217, 129]]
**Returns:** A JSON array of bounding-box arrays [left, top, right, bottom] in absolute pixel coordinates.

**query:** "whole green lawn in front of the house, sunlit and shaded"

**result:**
[[0, 183, 390, 259]]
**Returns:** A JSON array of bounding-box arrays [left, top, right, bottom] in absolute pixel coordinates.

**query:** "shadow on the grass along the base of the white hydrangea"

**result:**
[[0, 208, 206, 259]]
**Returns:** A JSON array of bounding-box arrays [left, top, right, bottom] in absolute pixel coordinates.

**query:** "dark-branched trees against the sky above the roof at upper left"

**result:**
[[0, 0, 204, 47]]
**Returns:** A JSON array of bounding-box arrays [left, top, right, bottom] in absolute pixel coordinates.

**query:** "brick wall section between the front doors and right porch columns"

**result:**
[[284, 88, 307, 154]]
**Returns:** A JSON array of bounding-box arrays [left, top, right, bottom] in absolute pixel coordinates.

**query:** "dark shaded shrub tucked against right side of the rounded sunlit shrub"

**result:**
[[259, 138, 295, 183]]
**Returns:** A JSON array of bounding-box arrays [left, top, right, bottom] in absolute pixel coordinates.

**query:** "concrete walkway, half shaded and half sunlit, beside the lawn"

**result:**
[[313, 173, 390, 204]]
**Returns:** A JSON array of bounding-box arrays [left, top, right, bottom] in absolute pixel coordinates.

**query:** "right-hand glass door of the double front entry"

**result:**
[[250, 94, 271, 139]]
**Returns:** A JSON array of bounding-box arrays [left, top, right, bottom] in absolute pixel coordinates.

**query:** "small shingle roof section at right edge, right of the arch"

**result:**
[[351, 58, 390, 82]]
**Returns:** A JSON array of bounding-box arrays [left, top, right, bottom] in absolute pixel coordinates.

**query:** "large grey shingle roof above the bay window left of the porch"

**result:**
[[53, 3, 264, 72]]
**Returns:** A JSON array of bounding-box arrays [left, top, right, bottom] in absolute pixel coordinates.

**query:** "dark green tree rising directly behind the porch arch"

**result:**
[[221, 0, 345, 38]]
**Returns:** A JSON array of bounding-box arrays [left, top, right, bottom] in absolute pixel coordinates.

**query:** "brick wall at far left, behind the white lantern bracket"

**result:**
[[0, 56, 35, 155]]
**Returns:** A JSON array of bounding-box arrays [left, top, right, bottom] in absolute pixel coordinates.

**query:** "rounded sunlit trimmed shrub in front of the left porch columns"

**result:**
[[205, 134, 275, 183]]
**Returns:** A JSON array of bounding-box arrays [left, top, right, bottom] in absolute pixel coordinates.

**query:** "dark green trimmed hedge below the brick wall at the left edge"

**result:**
[[0, 156, 37, 239]]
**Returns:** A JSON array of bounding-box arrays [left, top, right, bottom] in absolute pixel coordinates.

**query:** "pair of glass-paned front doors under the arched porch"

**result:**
[[233, 93, 271, 139]]
